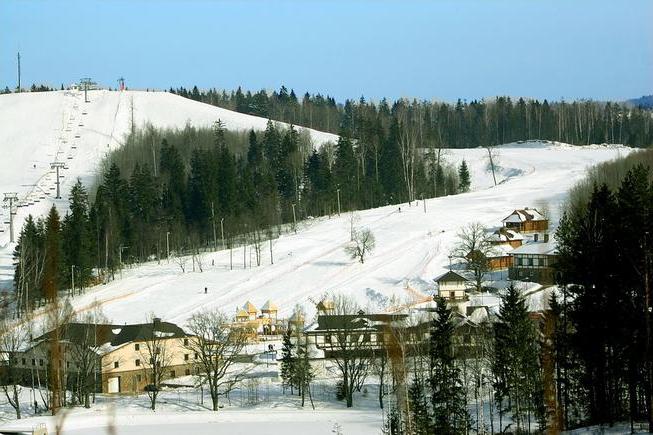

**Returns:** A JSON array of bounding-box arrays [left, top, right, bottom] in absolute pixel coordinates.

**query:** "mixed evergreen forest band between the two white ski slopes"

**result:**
[[14, 121, 470, 309]]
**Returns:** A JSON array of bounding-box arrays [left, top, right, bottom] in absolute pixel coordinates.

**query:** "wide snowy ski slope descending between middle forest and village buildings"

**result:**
[[52, 142, 630, 325]]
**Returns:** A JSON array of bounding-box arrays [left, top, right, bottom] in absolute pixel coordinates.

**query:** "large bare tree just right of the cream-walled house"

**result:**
[[186, 311, 252, 411]]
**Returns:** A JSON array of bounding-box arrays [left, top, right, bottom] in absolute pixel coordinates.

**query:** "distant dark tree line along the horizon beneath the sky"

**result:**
[[170, 86, 653, 148]]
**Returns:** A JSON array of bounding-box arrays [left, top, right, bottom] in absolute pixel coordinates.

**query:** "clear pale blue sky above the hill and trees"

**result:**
[[0, 0, 653, 101]]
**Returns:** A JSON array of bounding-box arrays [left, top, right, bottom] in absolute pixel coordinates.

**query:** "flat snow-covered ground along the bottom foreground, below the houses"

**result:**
[[0, 365, 383, 435]]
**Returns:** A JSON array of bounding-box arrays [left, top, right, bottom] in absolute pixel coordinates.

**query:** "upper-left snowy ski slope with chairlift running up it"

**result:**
[[0, 90, 337, 290]]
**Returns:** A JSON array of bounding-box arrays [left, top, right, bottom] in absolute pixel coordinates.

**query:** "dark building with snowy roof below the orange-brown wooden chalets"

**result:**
[[508, 242, 558, 284]]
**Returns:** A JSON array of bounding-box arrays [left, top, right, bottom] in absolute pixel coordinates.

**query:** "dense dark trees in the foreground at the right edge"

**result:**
[[551, 150, 653, 429]]
